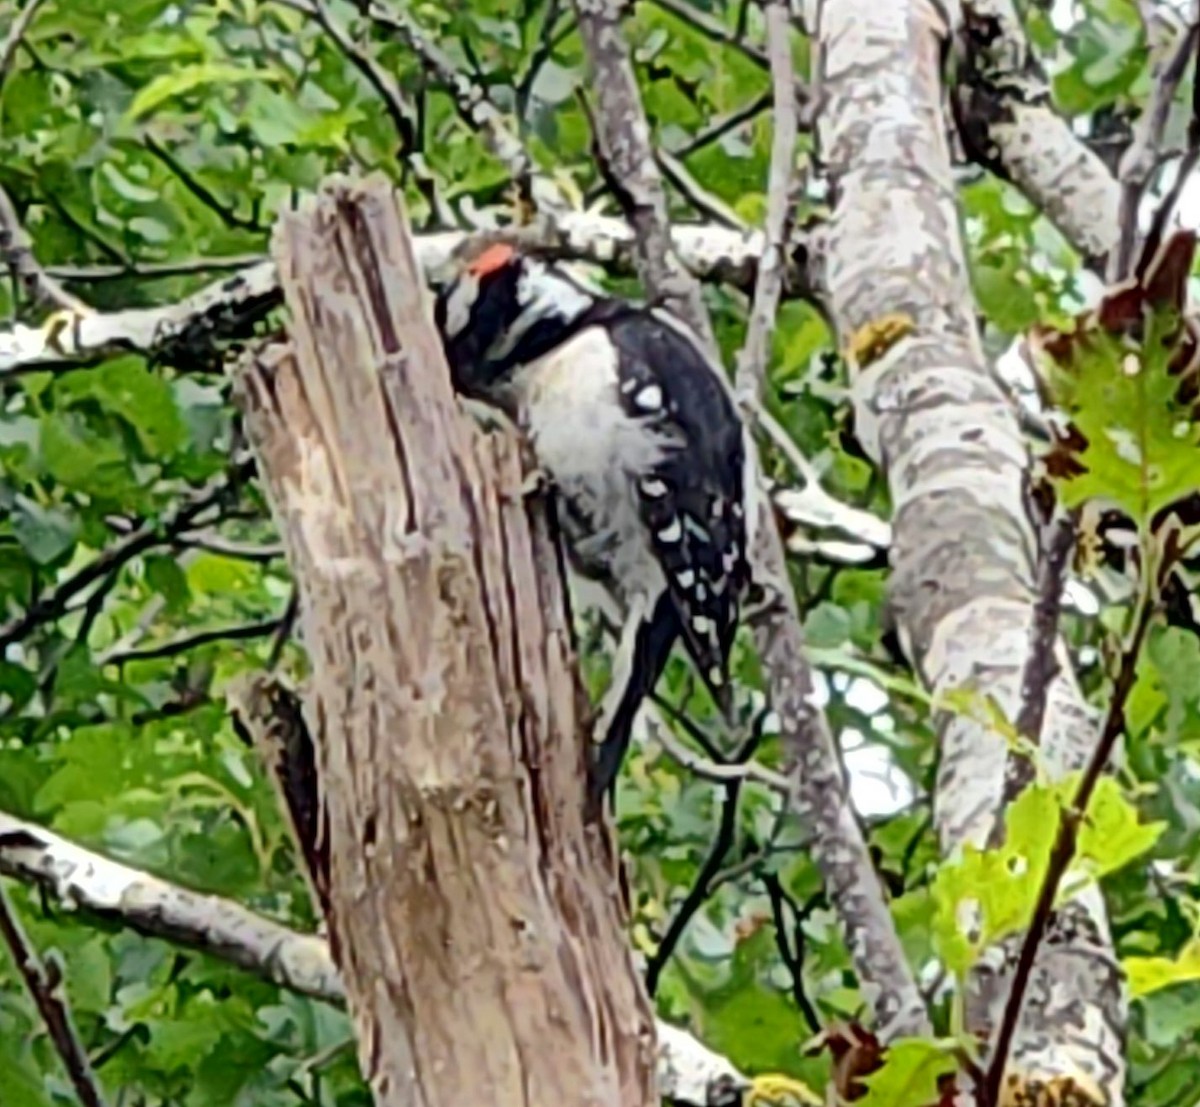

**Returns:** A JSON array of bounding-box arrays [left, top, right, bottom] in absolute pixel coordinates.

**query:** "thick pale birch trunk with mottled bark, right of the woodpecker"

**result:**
[[820, 0, 1124, 1107]]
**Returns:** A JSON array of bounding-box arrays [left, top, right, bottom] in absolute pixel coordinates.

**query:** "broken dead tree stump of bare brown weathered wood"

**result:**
[[239, 172, 656, 1107]]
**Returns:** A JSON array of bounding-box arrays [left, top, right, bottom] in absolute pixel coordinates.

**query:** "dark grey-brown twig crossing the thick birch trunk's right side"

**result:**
[[992, 511, 1076, 821]]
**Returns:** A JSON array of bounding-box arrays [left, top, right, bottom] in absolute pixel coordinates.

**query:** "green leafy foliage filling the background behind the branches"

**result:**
[[0, 0, 1200, 1107]]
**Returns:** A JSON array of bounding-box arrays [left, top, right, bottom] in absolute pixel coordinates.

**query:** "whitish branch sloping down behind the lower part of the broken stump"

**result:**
[[0, 812, 749, 1107]]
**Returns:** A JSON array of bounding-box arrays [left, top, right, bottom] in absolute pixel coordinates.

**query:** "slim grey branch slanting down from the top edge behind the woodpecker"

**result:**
[[575, 0, 929, 1040]]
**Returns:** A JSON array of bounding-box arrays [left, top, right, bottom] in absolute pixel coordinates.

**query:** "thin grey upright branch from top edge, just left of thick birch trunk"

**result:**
[[734, 0, 799, 403]]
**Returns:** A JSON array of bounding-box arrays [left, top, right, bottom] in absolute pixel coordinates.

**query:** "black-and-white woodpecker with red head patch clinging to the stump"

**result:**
[[434, 245, 754, 802]]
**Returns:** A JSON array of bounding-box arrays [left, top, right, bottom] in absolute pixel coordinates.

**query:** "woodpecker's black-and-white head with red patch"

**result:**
[[433, 243, 596, 399]]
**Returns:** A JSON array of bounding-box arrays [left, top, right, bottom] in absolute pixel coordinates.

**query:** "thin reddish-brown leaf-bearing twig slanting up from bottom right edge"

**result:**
[[984, 583, 1156, 1107]]
